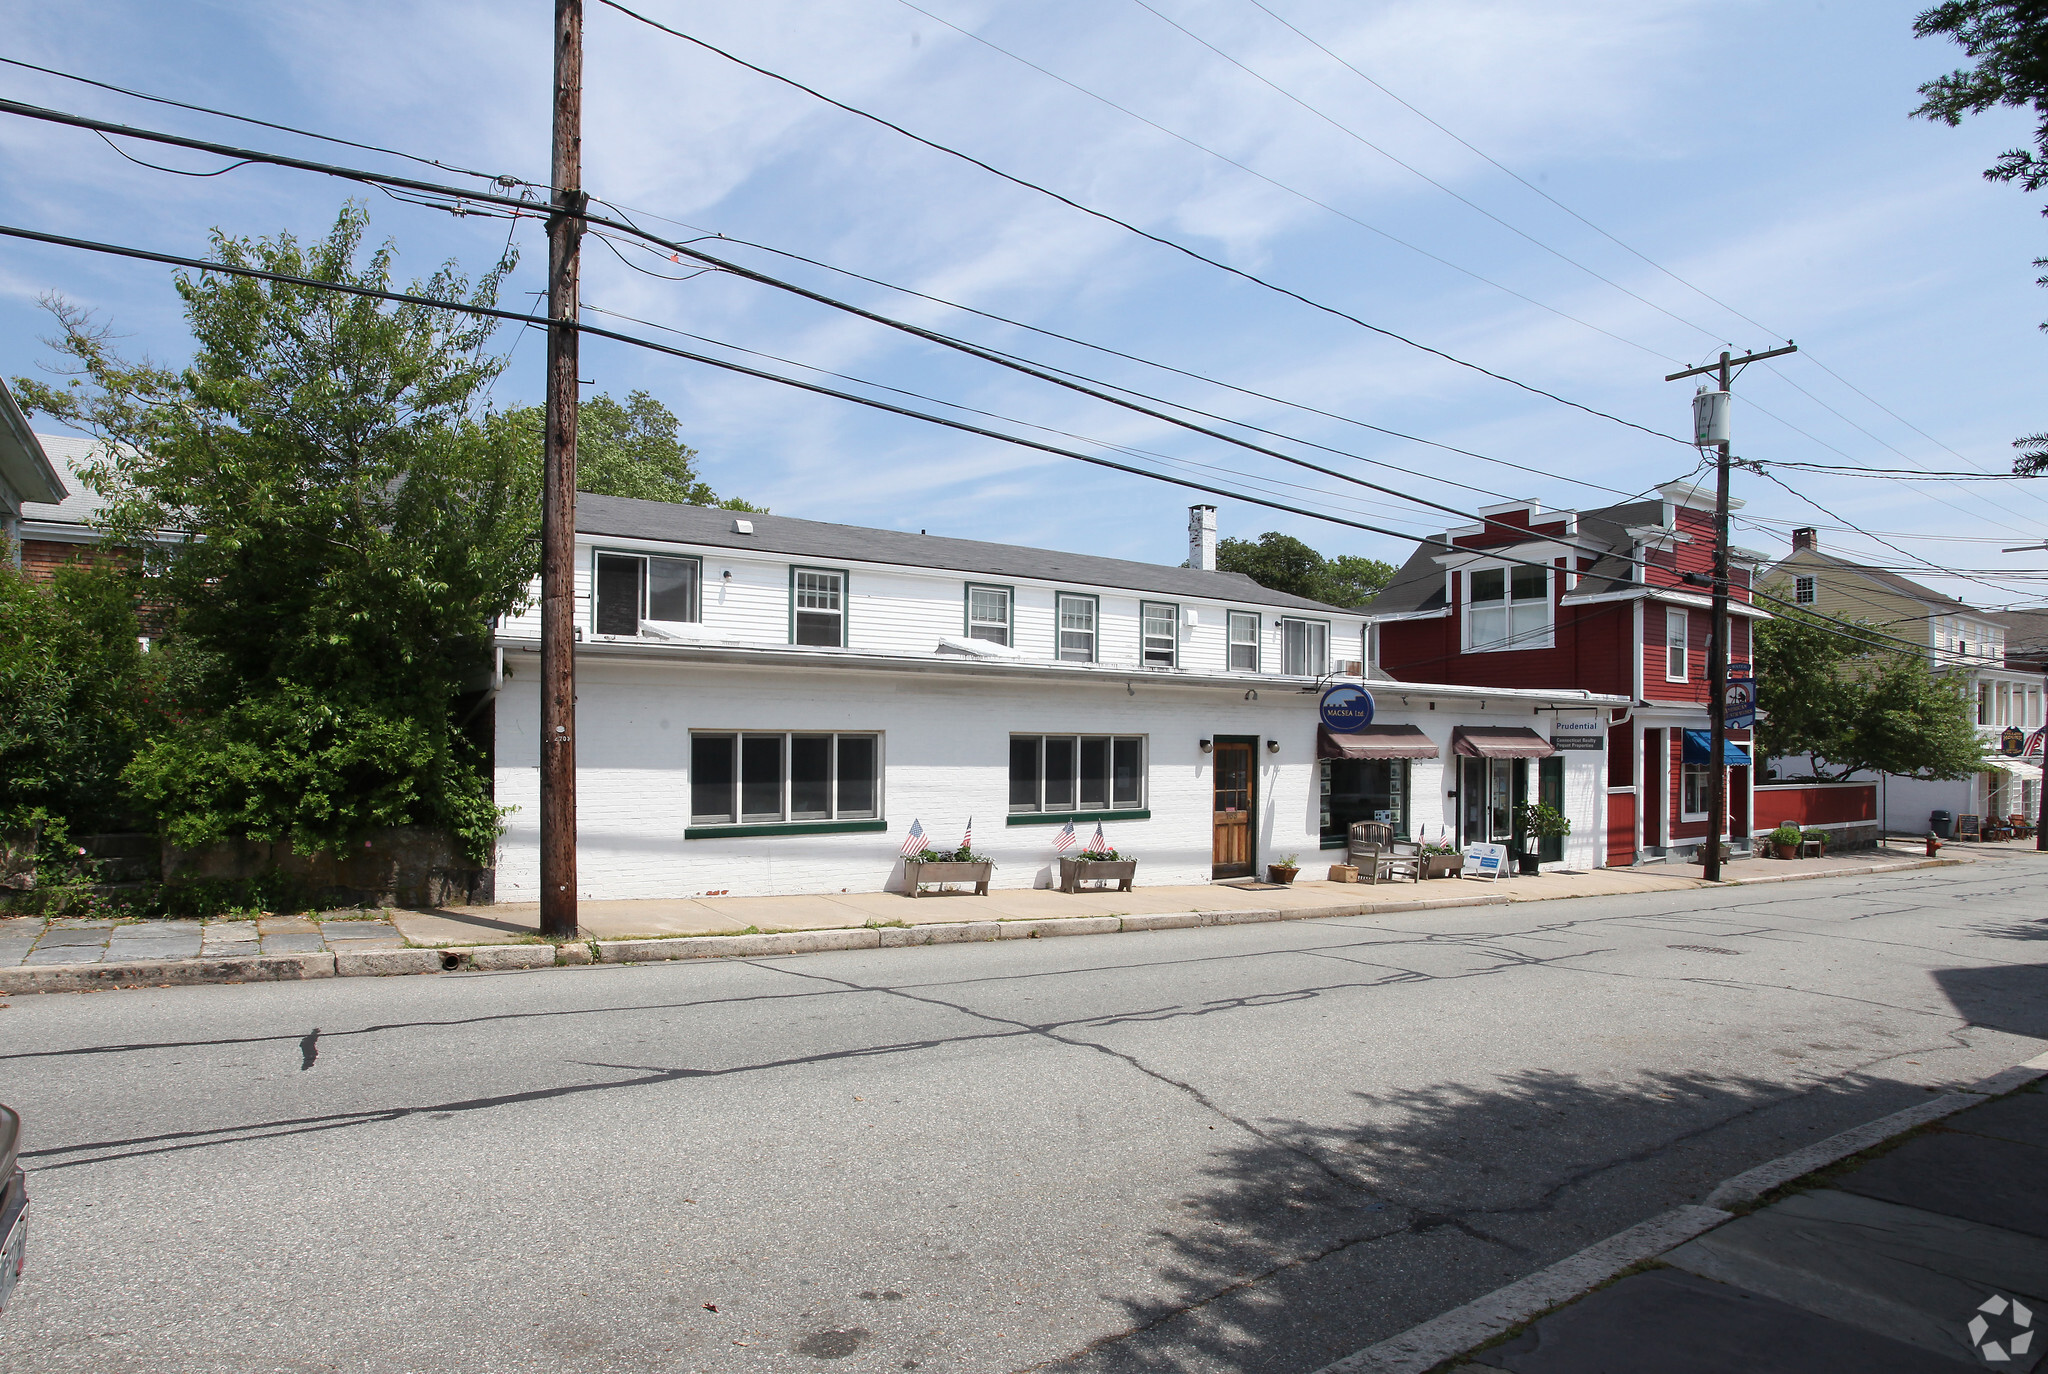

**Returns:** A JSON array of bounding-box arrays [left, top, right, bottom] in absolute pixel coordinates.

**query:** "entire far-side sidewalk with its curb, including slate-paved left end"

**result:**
[[0, 850, 1989, 993]]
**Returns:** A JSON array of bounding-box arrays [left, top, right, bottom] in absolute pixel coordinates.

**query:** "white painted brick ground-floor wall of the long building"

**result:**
[[496, 651, 1606, 901]]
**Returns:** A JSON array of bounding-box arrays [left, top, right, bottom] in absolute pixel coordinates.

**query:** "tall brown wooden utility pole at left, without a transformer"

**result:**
[[541, 0, 586, 938]]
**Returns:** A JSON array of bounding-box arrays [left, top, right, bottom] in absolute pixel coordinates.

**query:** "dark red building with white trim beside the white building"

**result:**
[[1366, 483, 1763, 866]]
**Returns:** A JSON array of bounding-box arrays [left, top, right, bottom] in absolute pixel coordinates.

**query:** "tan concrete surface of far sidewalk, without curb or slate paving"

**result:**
[[391, 850, 1964, 946]]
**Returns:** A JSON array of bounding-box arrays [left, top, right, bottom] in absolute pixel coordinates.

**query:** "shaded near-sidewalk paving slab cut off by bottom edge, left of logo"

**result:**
[[1473, 1270, 1956, 1374]]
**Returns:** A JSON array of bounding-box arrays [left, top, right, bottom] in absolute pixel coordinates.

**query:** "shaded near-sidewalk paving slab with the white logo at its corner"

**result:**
[[1665, 1188, 2048, 1374]]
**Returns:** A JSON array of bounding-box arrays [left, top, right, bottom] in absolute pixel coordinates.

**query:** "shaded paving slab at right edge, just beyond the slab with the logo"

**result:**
[[1835, 1130, 2048, 1239]]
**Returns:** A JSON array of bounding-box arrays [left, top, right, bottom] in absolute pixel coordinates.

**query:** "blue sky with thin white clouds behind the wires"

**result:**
[[0, 0, 2048, 606]]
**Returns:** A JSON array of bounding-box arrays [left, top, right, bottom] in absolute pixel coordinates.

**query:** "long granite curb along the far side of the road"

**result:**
[[0, 858, 1972, 995]]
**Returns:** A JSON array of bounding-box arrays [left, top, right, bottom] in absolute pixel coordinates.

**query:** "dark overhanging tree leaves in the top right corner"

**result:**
[[1913, 0, 2048, 477]]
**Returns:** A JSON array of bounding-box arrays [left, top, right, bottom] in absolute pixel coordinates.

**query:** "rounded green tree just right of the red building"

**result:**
[[1755, 610, 1985, 780]]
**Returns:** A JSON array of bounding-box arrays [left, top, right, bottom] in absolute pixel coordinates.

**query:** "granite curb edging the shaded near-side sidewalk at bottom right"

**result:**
[[1315, 1055, 2048, 1374]]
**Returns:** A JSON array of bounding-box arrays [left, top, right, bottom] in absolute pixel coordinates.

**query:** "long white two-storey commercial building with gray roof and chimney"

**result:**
[[492, 496, 1626, 901]]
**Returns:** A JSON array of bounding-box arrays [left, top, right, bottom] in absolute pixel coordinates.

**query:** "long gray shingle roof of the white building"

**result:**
[[575, 491, 1341, 610]]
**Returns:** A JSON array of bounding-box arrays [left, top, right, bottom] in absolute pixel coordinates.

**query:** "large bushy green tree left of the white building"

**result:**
[[16, 205, 539, 858]]
